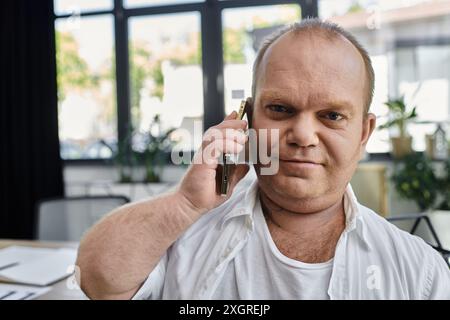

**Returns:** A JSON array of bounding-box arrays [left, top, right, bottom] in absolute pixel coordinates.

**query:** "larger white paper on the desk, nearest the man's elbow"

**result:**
[[0, 248, 77, 286]]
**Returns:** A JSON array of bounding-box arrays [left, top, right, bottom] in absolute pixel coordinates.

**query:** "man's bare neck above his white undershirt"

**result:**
[[260, 192, 345, 263]]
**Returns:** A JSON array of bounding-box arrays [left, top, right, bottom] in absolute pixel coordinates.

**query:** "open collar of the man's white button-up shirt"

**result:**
[[221, 170, 369, 248]]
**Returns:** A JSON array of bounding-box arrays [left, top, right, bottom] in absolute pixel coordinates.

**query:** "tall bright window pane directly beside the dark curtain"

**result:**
[[55, 15, 117, 159]]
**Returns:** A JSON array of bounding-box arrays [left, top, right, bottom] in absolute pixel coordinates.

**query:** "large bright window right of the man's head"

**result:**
[[319, 0, 450, 153]]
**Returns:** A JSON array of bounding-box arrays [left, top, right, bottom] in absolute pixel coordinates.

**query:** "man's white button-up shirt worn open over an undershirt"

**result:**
[[134, 170, 450, 299]]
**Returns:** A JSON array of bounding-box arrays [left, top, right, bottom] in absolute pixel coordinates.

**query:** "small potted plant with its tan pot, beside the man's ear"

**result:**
[[379, 96, 417, 159]]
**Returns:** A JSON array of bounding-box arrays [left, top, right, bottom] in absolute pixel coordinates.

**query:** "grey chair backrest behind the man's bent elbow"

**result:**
[[34, 196, 130, 241]]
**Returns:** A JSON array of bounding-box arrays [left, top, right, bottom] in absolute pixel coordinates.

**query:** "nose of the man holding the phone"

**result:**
[[286, 114, 319, 147]]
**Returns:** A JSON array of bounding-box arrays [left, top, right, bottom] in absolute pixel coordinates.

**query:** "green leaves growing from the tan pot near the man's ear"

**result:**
[[378, 96, 417, 138]]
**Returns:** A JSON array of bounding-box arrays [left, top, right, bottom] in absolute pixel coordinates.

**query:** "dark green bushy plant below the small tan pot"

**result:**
[[391, 153, 440, 211]]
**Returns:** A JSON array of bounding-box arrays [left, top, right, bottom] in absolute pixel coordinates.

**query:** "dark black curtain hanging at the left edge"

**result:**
[[0, 0, 64, 239]]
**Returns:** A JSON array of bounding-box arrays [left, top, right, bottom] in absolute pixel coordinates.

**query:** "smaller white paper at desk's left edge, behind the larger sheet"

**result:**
[[0, 246, 55, 269]]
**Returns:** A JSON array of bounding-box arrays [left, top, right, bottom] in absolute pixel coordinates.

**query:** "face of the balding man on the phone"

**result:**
[[252, 32, 375, 213]]
